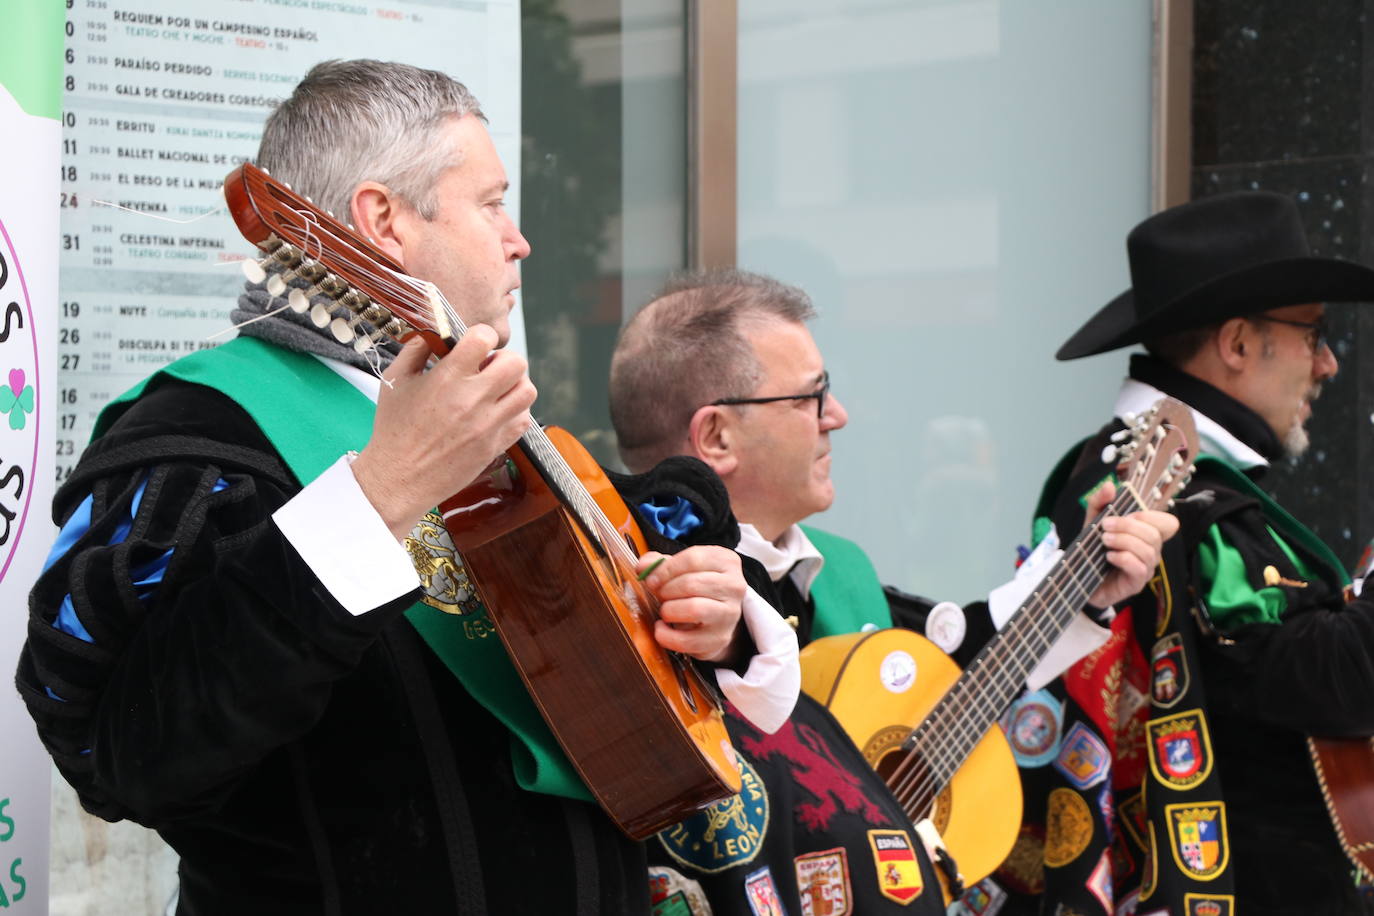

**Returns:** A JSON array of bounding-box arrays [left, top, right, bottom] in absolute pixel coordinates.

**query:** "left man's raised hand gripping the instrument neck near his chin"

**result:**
[[353, 324, 534, 541]]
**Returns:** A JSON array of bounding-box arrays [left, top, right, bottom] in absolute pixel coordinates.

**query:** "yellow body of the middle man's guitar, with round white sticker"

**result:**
[[801, 629, 1021, 884]]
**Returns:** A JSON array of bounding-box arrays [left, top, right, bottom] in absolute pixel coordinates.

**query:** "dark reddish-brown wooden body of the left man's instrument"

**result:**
[[440, 428, 741, 839]]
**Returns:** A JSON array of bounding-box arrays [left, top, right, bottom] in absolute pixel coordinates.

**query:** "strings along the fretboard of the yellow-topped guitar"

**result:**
[[888, 439, 1172, 817]]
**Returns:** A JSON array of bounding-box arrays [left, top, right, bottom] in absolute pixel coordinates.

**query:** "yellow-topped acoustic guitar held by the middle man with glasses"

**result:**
[[801, 398, 1197, 895]]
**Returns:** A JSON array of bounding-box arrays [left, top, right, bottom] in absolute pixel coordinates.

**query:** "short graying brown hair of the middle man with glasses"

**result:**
[[610, 269, 816, 471]]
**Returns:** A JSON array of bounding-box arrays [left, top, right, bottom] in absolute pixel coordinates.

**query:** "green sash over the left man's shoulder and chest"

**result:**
[[93, 338, 592, 801]]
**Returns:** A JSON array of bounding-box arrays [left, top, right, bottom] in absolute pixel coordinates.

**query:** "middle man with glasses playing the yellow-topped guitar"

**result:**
[[610, 271, 1173, 916]]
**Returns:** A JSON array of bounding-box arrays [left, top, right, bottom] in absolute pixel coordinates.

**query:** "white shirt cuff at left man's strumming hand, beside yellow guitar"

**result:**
[[716, 589, 801, 735]]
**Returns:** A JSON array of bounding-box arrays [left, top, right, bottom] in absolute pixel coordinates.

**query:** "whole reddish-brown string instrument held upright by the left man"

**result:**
[[224, 163, 741, 839]]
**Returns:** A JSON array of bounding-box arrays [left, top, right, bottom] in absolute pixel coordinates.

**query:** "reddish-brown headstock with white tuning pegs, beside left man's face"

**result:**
[[224, 162, 463, 356]]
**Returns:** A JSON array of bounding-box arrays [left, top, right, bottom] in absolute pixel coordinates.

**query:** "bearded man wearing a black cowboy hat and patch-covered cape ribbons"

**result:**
[[1003, 191, 1374, 916]]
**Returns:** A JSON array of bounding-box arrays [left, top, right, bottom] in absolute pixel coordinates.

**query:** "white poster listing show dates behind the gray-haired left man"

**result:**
[[58, 0, 523, 479]]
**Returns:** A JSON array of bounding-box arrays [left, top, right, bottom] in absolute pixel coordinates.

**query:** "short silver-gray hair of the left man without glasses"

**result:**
[[257, 60, 486, 222]]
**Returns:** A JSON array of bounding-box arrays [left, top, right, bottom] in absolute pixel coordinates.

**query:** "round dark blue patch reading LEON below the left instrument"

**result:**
[[658, 757, 768, 875]]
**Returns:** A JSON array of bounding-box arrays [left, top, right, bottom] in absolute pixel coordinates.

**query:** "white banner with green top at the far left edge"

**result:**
[[0, 0, 62, 915]]
